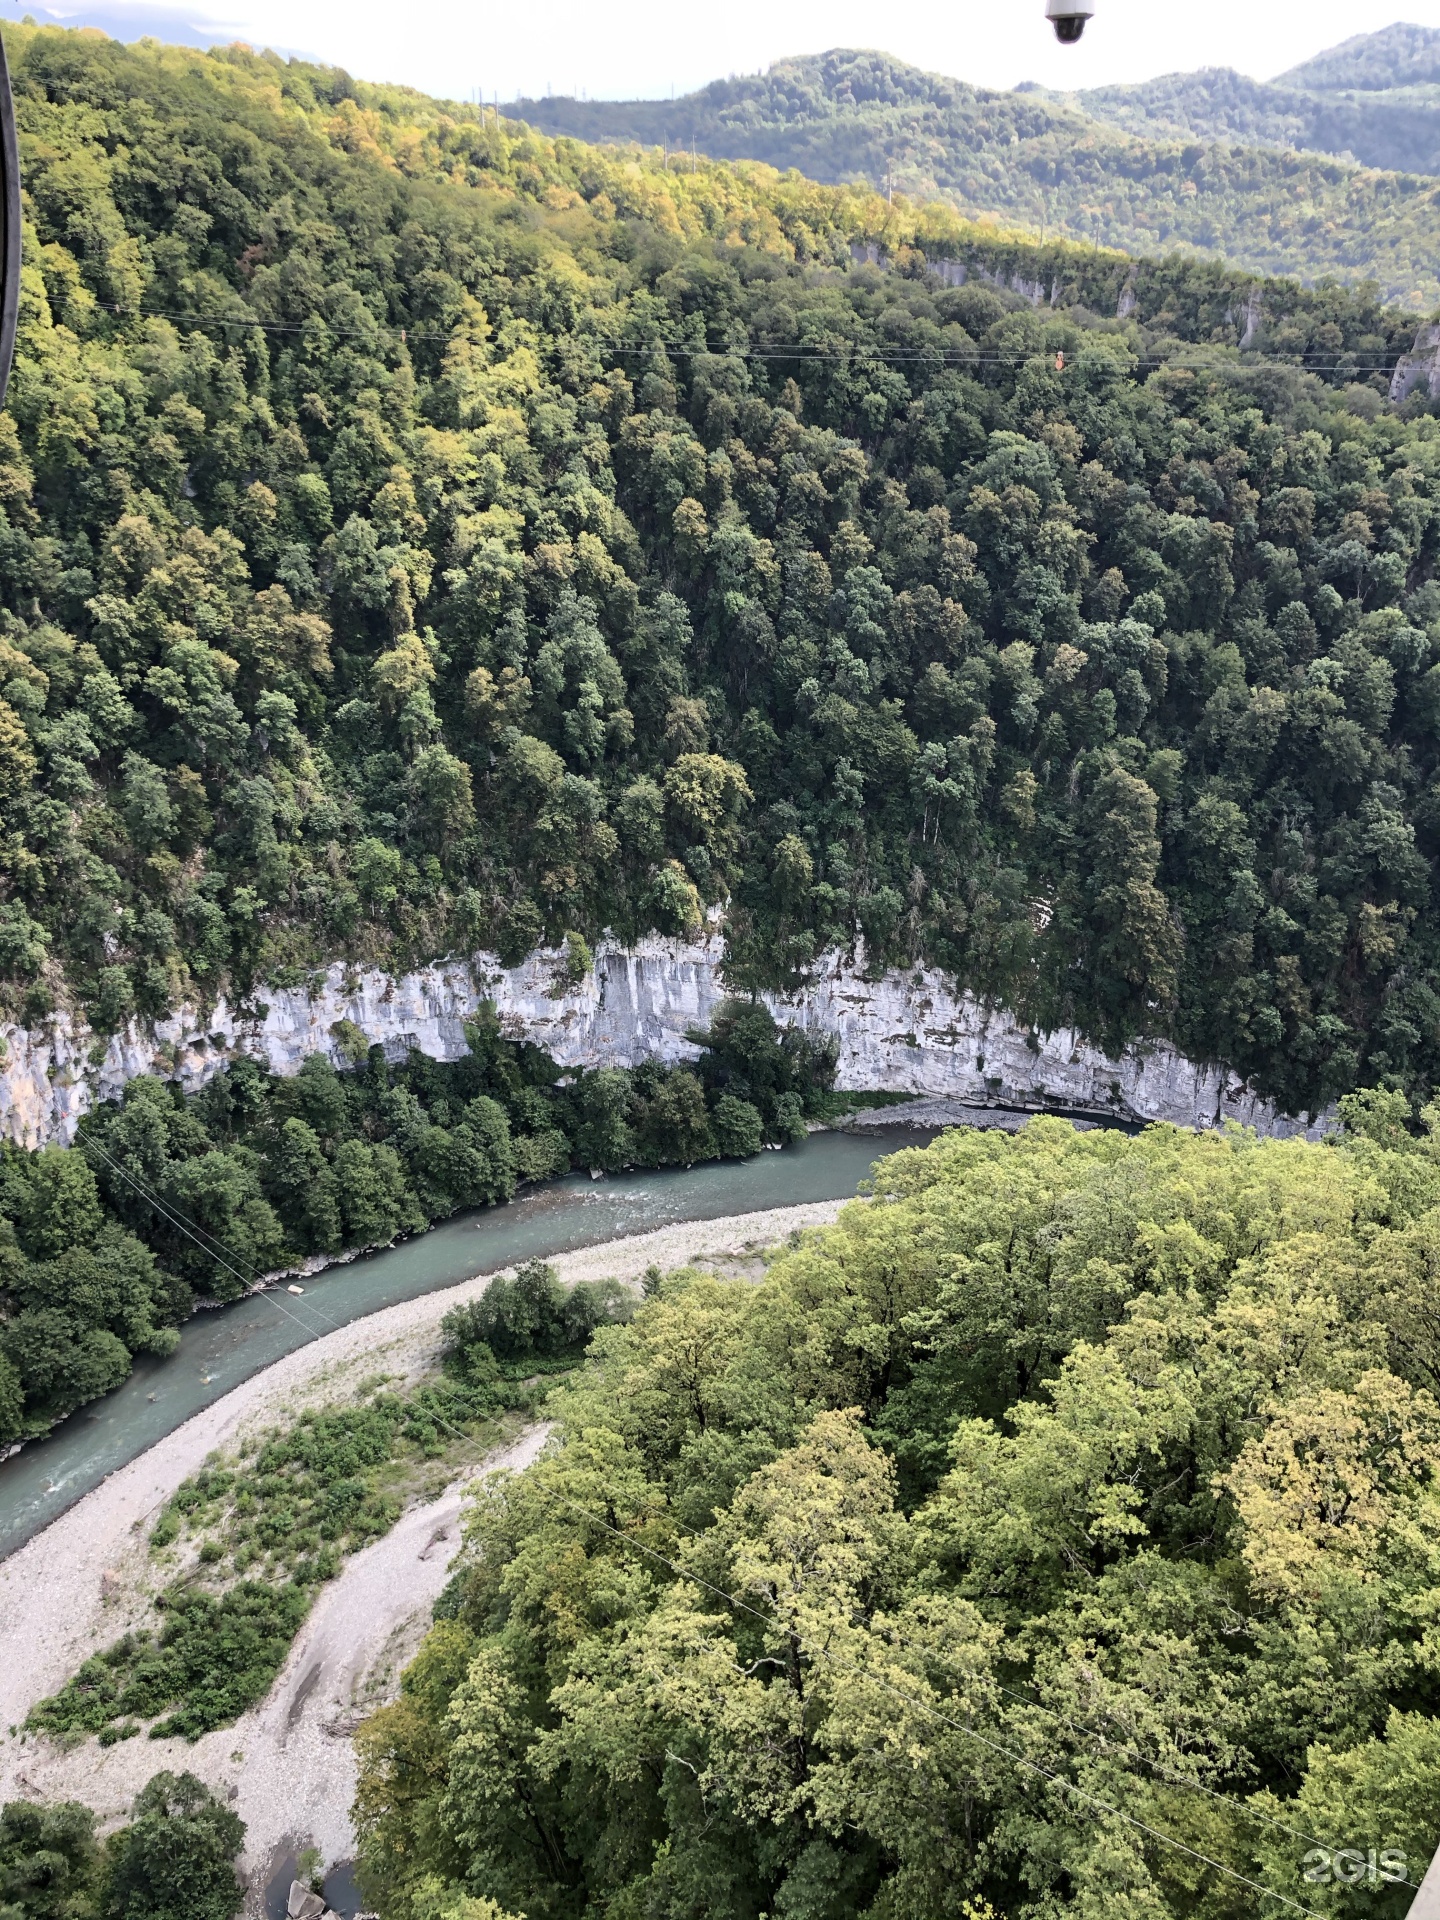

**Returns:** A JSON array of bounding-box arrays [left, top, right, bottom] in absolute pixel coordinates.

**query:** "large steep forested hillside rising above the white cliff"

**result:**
[[0, 29, 1440, 1108]]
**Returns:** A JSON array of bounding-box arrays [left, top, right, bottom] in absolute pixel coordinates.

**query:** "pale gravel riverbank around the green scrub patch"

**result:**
[[0, 1200, 845, 1908]]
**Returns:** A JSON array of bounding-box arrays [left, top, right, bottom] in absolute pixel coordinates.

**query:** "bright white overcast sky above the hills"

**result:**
[[11, 0, 1440, 100]]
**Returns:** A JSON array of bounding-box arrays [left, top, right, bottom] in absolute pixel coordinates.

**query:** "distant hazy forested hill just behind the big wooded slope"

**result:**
[[511, 48, 1440, 309]]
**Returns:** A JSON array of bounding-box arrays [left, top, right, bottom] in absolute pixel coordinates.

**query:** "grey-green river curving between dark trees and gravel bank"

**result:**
[[0, 1129, 931, 1559]]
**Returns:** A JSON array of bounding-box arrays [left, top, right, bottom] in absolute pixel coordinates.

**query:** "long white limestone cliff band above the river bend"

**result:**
[[0, 933, 1321, 1146]]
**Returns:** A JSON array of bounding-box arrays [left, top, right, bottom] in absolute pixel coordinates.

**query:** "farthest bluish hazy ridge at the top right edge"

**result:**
[[1075, 25, 1440, 173]]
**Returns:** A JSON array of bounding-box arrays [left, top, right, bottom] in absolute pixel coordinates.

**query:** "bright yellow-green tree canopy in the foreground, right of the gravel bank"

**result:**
[[357, 1096, 1440, 1920]]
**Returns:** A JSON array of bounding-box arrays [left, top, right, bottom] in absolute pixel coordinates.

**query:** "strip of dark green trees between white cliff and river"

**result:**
[[0, 1004, 835, 1444]]
